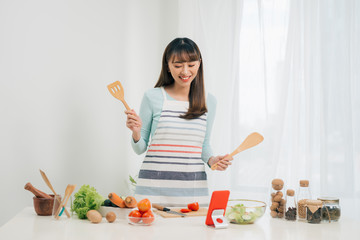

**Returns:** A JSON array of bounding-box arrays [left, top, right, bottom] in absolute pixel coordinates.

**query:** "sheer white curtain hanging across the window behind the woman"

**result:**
[[179, 0, 360, 200]]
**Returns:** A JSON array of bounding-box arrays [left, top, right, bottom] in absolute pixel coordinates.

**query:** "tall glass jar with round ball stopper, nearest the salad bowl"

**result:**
[[270, 178, 285, 218]]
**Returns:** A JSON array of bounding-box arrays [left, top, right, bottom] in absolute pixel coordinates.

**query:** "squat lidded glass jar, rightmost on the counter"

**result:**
[[318, 197, 341, 223]]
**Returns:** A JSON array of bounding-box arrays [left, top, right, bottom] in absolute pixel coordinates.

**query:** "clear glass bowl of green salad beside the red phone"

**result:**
[[225, 199, 266, 224]]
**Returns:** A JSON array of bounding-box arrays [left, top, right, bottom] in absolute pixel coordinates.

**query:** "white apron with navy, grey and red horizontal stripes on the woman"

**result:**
[[135, 92, 209, 206]]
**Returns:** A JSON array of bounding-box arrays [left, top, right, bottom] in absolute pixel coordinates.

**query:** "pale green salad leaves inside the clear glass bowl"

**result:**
[[225, 204, 264, 224]]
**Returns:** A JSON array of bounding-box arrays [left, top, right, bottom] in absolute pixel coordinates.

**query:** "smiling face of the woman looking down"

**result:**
[[168, 56, 200, 88]]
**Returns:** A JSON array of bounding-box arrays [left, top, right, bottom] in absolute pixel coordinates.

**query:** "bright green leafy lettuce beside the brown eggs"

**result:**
[[71, 185, 105, 219]]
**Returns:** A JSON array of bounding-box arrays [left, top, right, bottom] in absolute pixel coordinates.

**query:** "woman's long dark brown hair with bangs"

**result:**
[[155, 38, 207, 119]]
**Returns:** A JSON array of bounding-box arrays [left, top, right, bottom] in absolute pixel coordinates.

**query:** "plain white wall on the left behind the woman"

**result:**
[[0, 0, 178, 226]]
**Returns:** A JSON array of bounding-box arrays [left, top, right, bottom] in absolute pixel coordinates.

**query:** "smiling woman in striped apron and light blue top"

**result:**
[[125, 38, 232, 206]]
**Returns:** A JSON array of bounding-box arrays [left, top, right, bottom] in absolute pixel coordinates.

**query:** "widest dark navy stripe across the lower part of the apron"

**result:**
[[139, 169, 207, 181]]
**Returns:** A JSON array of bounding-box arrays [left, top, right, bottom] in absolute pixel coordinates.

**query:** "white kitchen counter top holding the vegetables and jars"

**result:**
[[0, 207, 360, 240]]
